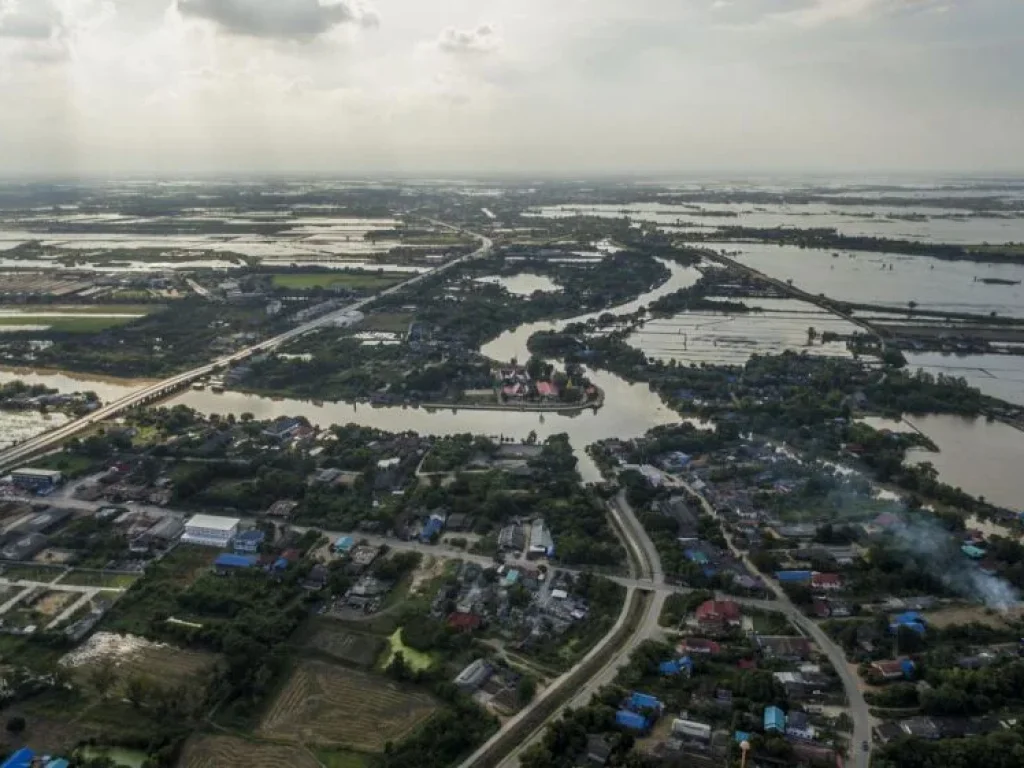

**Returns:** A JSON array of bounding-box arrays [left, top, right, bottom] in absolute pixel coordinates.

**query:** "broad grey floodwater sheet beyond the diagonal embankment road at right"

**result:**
[[709, 243, 1024, 317]]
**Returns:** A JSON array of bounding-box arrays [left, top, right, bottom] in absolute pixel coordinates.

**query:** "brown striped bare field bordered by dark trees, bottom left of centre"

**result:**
[[258, 660, 436, 752]]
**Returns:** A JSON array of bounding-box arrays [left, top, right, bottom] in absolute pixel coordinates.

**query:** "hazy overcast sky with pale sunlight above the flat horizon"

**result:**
[[0, 0, 1024, 174]]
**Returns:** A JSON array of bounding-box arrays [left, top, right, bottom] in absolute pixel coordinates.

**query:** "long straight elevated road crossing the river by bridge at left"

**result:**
[[0, 221, 493, 471]]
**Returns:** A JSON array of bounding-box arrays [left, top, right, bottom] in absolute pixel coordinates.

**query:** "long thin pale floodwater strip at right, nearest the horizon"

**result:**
[[526, 202, 1024, 245]]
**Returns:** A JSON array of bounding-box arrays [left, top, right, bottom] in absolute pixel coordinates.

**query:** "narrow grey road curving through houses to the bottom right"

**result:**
[[673, 478, 871, 768]]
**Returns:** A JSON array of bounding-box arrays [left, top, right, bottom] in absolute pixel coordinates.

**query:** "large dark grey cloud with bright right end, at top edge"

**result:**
[[177, 0, 378, 40]]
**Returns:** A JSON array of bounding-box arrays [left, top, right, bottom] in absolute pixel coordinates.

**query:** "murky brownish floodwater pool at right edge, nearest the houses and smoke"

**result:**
[[863, 415, 1024, 512]]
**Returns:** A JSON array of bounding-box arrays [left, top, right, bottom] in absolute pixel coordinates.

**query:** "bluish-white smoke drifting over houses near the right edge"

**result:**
[[889, 515, 1020, 611]]
